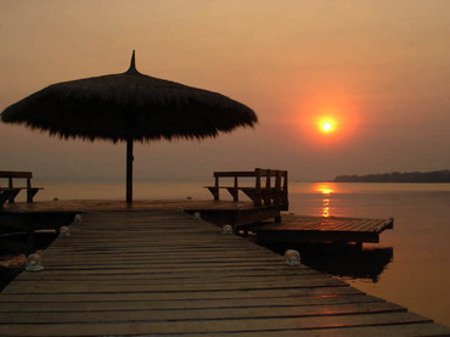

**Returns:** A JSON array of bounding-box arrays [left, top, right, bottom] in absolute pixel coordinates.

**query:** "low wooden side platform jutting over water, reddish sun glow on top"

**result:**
[[251, 214, 394, 242]]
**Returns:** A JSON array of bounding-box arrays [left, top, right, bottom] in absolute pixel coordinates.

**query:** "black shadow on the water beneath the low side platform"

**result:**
[[257, 242, 394, 283]]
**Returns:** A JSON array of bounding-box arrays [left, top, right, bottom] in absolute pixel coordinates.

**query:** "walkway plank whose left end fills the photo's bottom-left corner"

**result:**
[[0, 312, 429, 337]]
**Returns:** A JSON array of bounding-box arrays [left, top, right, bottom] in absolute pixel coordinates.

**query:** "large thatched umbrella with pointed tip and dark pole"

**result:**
[[1, 51, 257, 202]]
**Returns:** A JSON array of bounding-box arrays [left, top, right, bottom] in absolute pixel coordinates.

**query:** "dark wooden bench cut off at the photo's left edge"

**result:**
[[0, 171, 44, 208]]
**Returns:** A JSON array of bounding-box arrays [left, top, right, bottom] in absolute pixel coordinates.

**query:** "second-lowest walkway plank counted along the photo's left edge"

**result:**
[[0, 302, 406, 325]]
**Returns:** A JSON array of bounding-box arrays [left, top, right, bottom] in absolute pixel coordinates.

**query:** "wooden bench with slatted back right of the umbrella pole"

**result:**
[[205, 168, 289, 211]]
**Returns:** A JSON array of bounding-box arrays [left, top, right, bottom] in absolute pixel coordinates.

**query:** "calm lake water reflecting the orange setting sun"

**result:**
[[12, 181, 450, 326]]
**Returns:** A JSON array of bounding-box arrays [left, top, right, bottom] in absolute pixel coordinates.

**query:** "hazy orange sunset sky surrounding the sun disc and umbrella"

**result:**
[[0, 0, 450, 180]]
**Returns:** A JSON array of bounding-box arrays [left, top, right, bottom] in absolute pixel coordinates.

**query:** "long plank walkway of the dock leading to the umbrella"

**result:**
[[0, 210, 450, 337]]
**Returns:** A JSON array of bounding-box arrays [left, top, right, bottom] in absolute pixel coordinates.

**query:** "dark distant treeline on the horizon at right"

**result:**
[[333, 170, 450, 183]]
